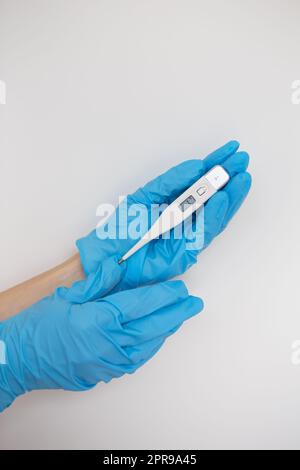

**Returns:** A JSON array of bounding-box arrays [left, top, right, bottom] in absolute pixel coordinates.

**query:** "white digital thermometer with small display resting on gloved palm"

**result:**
[[119, 165, 230, 264]]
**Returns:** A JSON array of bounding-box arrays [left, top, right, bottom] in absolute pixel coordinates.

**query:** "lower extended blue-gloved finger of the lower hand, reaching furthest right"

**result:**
[[123, 296, 203, 346]]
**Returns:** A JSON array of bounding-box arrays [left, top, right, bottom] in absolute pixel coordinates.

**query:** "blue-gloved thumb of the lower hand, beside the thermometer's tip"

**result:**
[[54, 256, 125, 304]]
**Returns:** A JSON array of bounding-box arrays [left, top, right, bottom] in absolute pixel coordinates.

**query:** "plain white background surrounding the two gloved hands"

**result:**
[[0, 0, 300, 449]]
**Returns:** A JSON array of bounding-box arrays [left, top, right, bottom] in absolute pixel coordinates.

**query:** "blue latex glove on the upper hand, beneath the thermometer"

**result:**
[[77, 141, 251, 291]]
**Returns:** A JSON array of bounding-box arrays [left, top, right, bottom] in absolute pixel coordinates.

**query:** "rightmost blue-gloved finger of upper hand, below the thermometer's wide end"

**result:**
[[220, 173, 252, 231]]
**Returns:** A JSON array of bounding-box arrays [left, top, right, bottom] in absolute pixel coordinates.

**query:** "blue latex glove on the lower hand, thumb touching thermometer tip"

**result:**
[[0, 255, 203, 411]]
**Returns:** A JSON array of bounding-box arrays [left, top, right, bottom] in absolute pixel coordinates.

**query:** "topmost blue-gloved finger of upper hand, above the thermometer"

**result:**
[[130, 141, 239, 204]]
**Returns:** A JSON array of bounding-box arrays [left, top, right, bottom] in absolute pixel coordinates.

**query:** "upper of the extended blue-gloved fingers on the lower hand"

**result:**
[[105, 281, 189, 324]]
